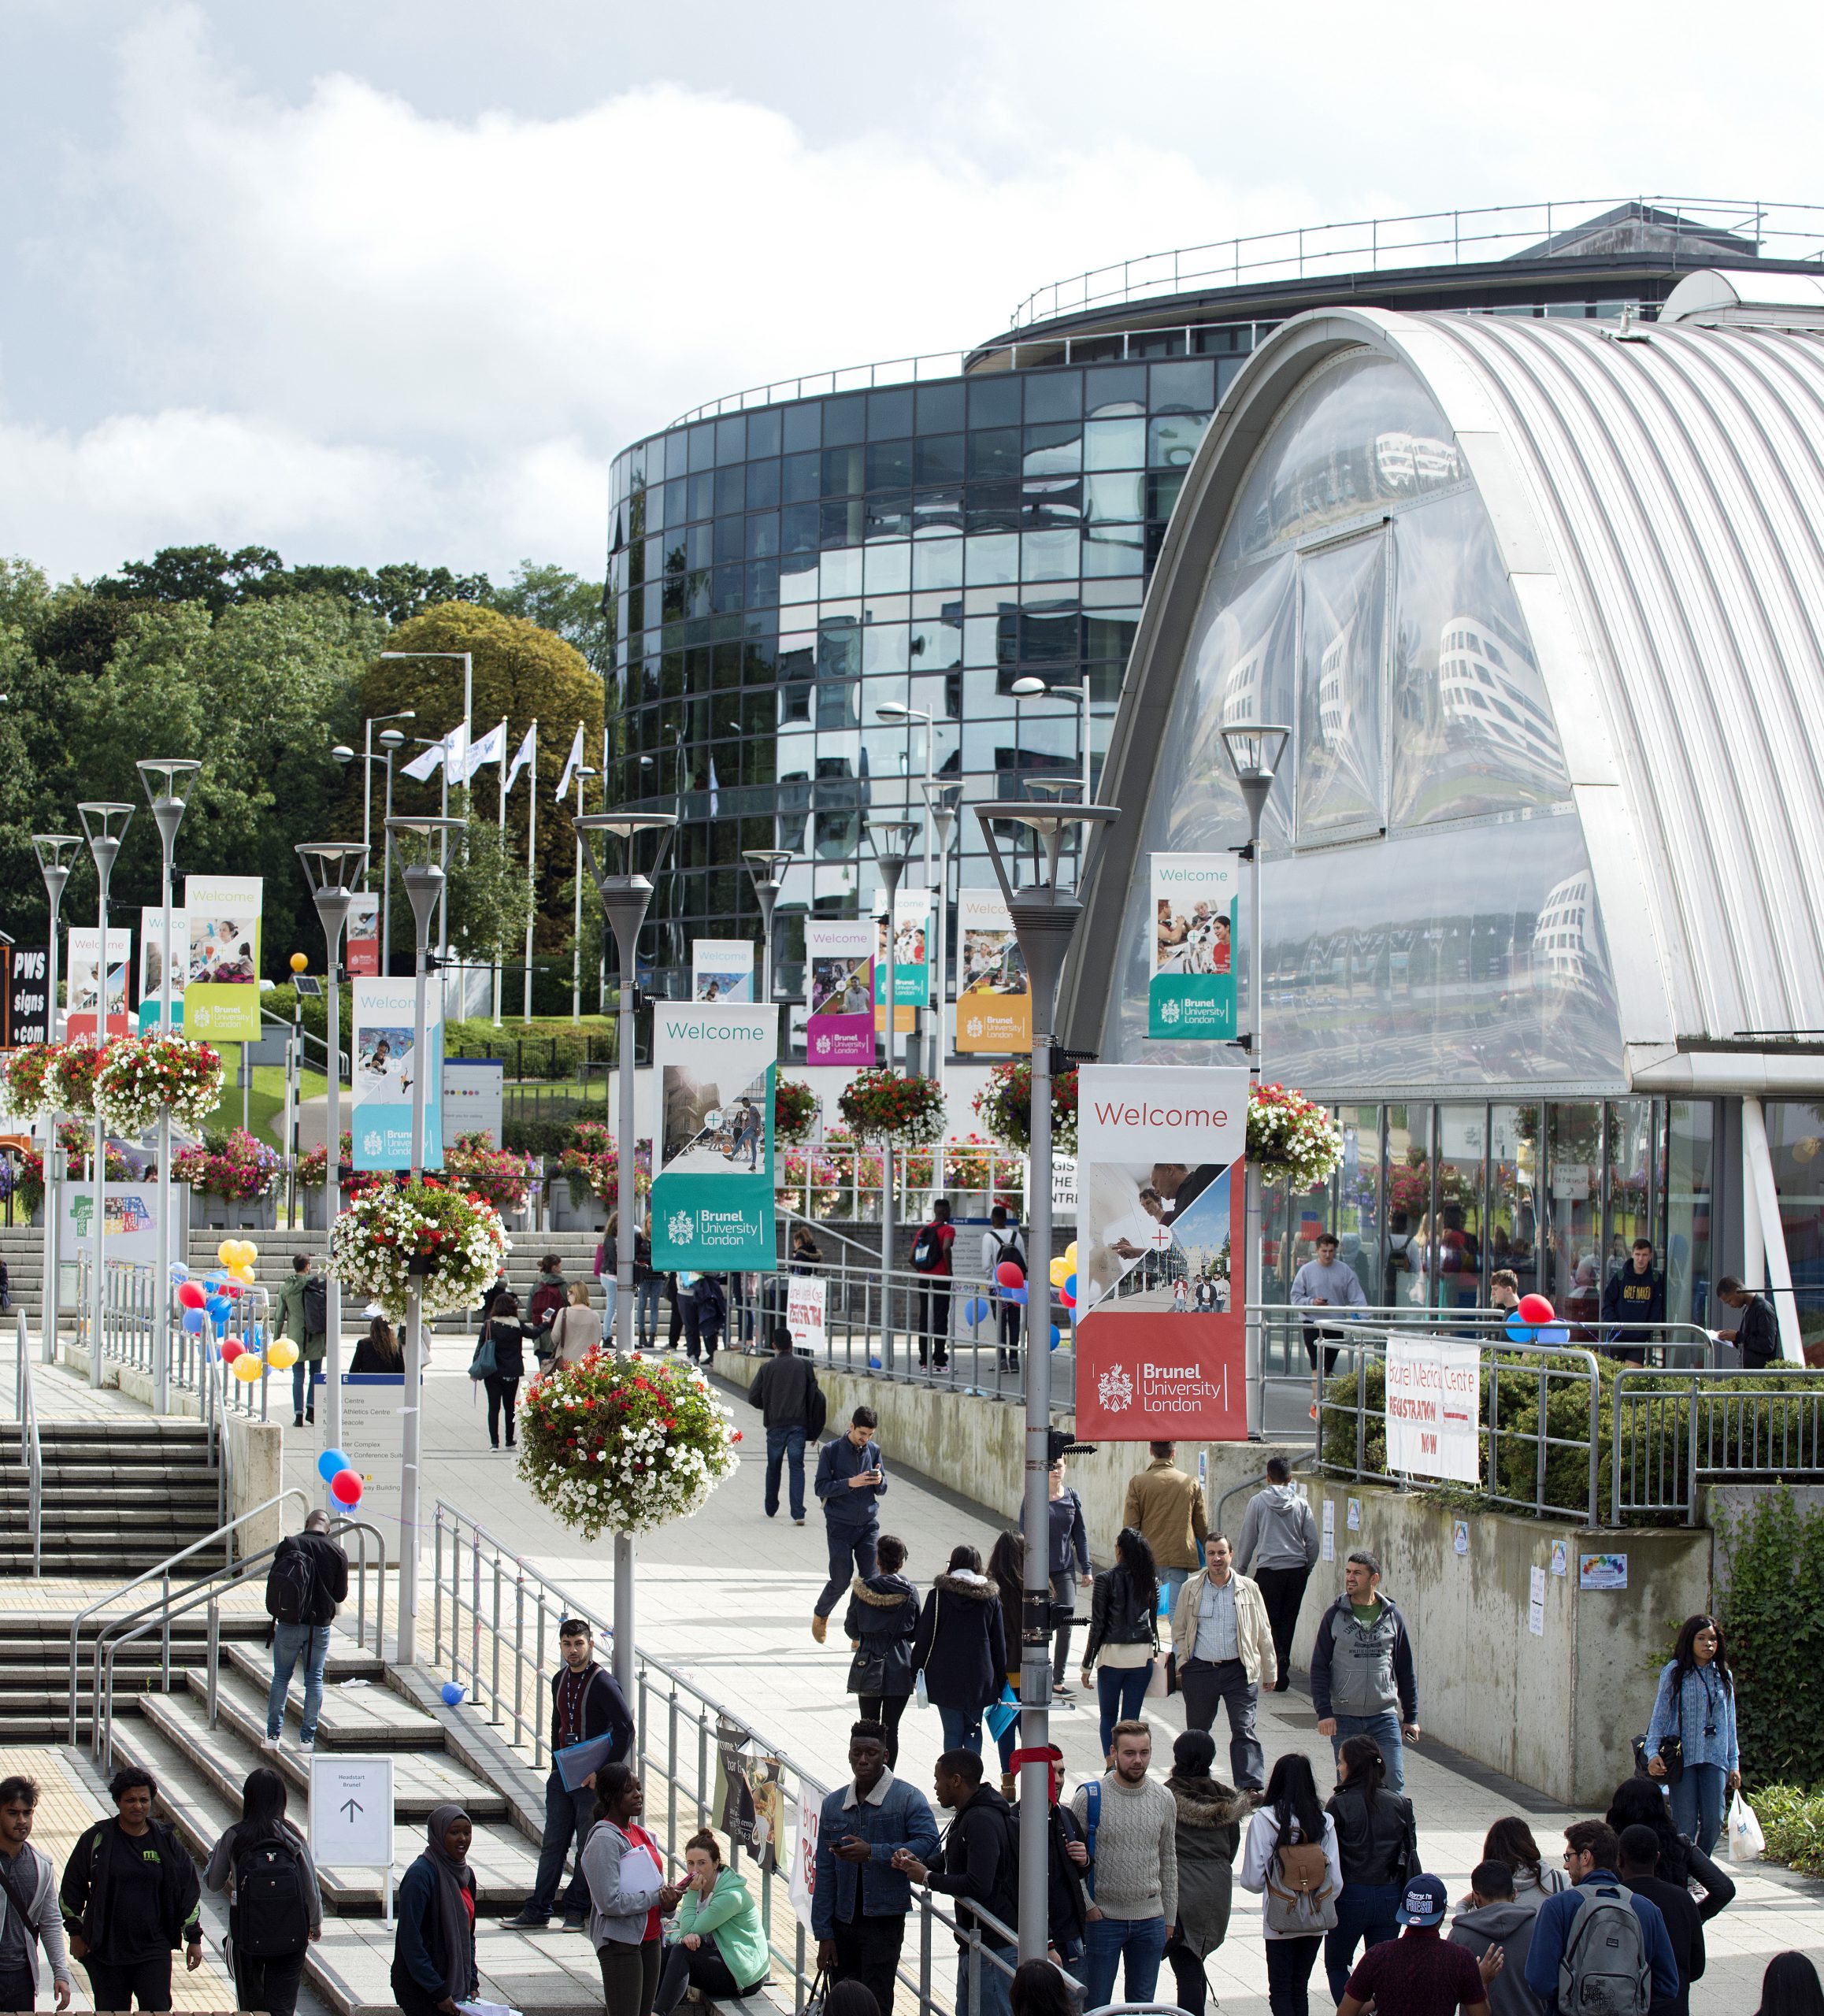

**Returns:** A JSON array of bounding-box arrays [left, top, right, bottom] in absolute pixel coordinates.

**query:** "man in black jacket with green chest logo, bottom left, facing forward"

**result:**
[[58, 1768, 203, 2010]]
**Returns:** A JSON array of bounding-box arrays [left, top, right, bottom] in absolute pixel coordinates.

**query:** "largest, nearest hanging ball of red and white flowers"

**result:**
[[520, 1351, 742, 1540]]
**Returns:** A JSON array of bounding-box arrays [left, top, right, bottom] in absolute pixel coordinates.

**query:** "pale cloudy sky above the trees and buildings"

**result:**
[[0, 0, 1824, 576]]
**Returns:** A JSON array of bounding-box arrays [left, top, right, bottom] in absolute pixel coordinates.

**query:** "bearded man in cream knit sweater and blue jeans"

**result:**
[[1070, 1721, 1177, 2010]]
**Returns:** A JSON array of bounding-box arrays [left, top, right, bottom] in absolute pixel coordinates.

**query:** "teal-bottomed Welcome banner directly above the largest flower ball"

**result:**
[[653, 1002, 778, 1274]]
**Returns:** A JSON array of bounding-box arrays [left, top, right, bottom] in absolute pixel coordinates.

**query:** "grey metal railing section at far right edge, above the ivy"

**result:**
[[1608, 1365, 1824, 1526]]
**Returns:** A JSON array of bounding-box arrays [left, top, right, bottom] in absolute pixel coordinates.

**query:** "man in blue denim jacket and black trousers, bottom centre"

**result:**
[[810, 1721, 937, 2016]]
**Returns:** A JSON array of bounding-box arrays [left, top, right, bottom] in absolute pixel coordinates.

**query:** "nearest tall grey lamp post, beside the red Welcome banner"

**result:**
[[976, 800, 1121, 1963]]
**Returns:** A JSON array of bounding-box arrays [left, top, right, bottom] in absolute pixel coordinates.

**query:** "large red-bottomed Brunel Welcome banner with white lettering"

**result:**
[[1077, 1065, 1248, 1441]]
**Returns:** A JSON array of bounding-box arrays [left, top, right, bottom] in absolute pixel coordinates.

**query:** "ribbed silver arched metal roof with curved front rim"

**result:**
[[1066, 294, 1824, 1079]]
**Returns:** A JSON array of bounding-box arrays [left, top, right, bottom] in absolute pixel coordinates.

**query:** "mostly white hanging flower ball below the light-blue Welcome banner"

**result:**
[[328, 1180, 508, 1322]]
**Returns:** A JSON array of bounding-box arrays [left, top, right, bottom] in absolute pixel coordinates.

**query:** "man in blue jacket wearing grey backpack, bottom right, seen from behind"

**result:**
[[1526, 1821, 1679, 2016]]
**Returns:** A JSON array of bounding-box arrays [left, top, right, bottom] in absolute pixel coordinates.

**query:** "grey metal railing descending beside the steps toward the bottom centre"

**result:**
[[432, 1498, 1081, 2016]]
